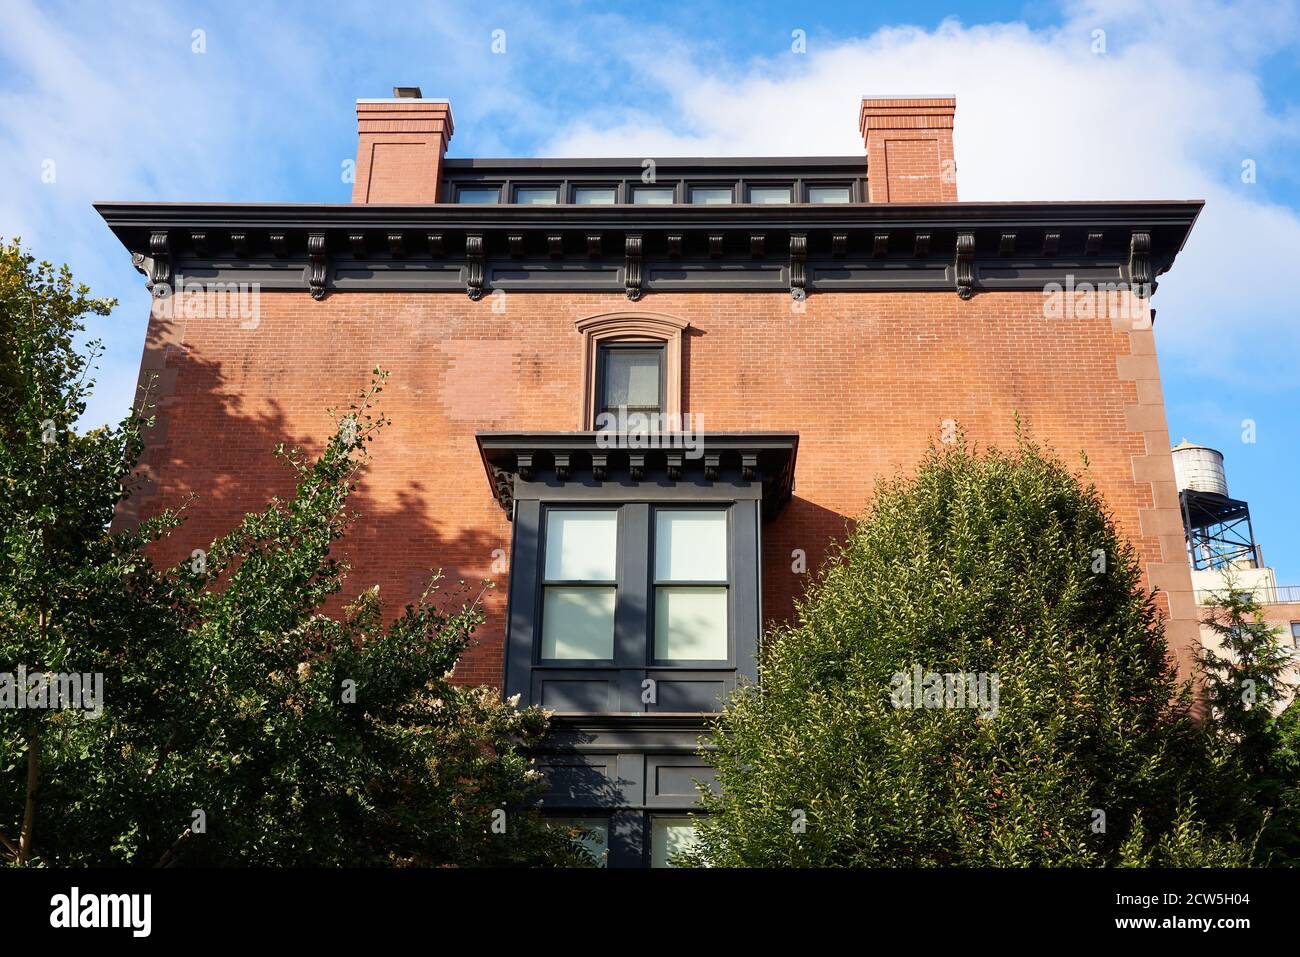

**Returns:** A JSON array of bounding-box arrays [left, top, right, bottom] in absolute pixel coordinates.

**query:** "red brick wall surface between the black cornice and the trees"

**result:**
[[133, 283, 1199, 683]]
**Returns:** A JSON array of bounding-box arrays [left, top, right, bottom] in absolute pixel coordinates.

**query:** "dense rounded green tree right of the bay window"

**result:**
[[683, 437, 1251, 866]]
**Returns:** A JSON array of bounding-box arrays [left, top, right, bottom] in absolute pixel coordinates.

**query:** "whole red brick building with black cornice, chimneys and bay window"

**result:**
[[98, 91, 1201, 866]]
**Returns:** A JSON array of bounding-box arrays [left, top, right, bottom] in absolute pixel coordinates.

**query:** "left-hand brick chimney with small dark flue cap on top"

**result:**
[[352, 87, 452, 203]]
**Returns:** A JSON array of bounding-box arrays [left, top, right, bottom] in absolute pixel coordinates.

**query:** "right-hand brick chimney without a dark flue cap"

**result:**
[[858, 96, 957, 203]]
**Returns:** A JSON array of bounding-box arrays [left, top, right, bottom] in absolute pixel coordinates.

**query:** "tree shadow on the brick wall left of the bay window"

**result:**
[[114, 343, 510, 685]]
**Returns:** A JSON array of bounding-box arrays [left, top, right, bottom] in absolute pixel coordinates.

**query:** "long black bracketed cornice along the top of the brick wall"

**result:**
[[95, 200, 1204, 299]]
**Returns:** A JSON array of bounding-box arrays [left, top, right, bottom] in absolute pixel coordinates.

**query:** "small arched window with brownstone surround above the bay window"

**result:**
[[576, 312, 690, 432]]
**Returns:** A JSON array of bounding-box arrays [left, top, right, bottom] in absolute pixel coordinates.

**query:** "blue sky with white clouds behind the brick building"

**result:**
[[0, 0, 1300, 584]]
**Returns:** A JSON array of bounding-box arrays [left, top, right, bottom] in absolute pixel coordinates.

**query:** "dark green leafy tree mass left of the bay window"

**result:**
[[0, 243, 582, 866]]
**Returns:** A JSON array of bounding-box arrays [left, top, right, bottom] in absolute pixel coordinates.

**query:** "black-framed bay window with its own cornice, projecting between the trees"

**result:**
[[477, 429, 798, 867]]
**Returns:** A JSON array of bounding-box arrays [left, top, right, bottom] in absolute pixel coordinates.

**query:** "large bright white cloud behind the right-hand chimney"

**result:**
[[542, 0, 1300, 386]]
